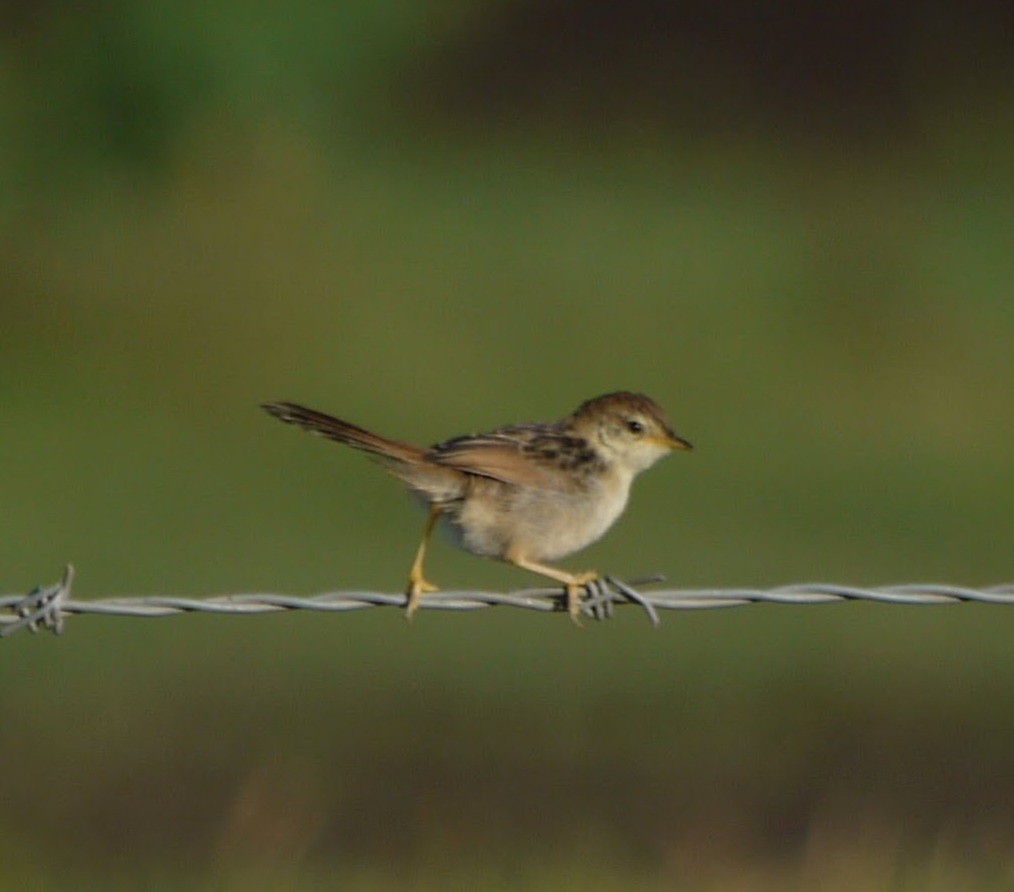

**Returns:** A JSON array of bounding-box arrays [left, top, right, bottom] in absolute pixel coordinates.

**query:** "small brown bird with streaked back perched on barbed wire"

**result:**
[[264, 391, 693, 622]]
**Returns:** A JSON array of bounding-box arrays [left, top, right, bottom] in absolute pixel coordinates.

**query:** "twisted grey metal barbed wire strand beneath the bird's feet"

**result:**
[[0, 564, 1014, 638]]
